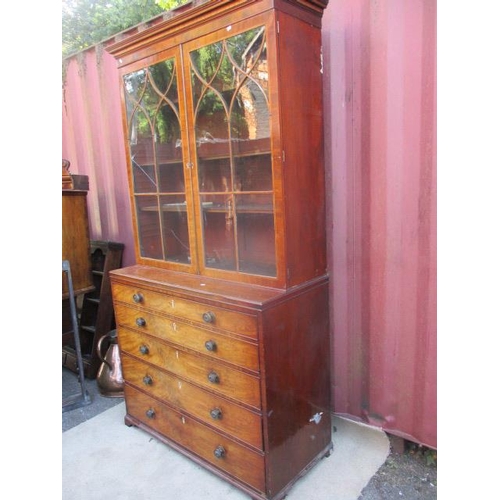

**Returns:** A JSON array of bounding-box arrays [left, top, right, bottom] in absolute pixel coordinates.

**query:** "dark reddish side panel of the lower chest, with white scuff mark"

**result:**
[[263, 283, 331, 496]]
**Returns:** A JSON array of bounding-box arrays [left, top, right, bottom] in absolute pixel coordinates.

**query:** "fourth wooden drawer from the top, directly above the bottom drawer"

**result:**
[[121, 355, 262, 450]]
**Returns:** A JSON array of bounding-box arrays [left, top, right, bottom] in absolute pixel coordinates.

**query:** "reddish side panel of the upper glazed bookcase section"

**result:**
[[278, 13, 326, 285]]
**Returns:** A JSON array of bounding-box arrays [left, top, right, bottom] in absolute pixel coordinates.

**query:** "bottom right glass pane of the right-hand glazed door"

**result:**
[[235, 195, 276, 276]]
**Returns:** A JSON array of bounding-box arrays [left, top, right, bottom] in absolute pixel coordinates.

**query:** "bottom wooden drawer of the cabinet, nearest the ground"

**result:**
[[125, 384, 264, 491]]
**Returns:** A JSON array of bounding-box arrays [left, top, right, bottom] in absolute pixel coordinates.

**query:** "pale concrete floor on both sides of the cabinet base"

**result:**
[[62, 369, 390, 500]]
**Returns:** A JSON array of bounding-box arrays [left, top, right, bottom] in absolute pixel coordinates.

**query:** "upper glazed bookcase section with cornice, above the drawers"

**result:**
[[108, 0, 326, 288]]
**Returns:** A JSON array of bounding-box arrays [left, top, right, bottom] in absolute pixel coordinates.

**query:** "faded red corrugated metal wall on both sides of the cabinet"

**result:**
[[63, 0, 437, 447]]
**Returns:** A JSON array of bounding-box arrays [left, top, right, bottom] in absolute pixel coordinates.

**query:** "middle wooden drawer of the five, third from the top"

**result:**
[[118, 327, 261, 410]]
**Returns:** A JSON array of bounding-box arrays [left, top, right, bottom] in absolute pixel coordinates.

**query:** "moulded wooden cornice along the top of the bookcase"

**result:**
[[106, 0, 329, 66]]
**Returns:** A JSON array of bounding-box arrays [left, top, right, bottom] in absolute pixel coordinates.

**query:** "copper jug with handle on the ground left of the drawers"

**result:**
[[96, 330, 123, 398]]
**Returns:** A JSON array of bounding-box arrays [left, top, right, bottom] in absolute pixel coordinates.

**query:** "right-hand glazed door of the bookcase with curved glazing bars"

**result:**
[[183, 18, 277, 281]]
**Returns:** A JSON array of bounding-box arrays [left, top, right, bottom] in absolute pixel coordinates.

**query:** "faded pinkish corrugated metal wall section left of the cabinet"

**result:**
[[62, 46, 135, 265]]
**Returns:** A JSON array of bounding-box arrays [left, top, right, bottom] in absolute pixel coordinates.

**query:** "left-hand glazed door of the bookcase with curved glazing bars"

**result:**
[[123, 50, 196, 271]]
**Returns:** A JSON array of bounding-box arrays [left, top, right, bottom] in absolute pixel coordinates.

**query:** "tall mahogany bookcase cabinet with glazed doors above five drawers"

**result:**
[[107, 0, 332, 499]]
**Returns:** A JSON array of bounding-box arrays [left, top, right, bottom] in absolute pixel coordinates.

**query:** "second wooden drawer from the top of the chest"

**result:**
[[115, 305, 259, 371]]
